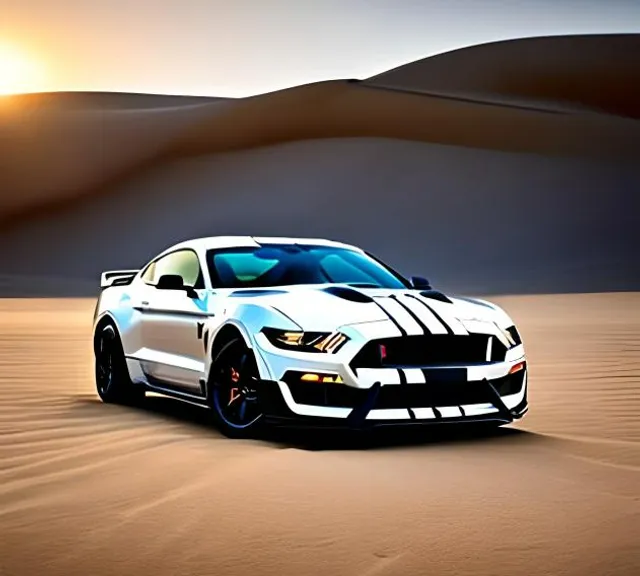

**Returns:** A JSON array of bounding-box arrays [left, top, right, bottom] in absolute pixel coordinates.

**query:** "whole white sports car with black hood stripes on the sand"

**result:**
[[94, 236, 527, 436]]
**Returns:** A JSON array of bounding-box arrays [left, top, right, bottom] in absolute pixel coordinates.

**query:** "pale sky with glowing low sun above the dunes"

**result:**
[[0, 0, 640, 97]]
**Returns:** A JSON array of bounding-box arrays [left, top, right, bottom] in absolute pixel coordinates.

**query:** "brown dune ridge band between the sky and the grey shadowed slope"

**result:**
[[0, 35, 640, 224]]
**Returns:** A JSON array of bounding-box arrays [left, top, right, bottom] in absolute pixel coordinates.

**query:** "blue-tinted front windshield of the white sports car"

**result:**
[[207, 244, 407, 288]]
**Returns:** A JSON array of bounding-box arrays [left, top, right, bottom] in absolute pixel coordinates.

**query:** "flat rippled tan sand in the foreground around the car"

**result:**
[[0, 293, 640, 576]]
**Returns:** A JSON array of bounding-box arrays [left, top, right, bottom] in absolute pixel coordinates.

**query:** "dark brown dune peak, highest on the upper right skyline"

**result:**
[[367, 34, 640, 119]]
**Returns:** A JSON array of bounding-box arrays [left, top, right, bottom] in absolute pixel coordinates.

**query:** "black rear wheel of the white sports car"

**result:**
[[95, 323, 144, 404]]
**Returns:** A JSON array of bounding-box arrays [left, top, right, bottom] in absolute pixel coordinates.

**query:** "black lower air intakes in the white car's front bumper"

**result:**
[[283, 371, 524, 409]]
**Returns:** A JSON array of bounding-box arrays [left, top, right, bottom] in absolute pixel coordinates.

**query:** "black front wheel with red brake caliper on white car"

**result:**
[[208, 336, 263, 438]]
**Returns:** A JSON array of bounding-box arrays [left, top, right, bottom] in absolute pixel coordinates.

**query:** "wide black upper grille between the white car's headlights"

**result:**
[[351, 334, 507, 370]]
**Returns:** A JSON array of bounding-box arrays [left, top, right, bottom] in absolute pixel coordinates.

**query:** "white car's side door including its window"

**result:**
[[138, 249, 209, 395]]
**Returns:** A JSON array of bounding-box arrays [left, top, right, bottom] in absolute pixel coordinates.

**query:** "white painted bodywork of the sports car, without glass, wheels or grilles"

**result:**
[[94, 236, 527, 428]]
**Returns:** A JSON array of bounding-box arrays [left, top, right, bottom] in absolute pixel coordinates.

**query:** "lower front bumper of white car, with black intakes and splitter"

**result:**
[[260, 370, 528, 429]]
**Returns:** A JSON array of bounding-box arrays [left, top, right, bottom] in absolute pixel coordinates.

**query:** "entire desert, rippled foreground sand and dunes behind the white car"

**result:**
[[0, 35, 640, 576]]
